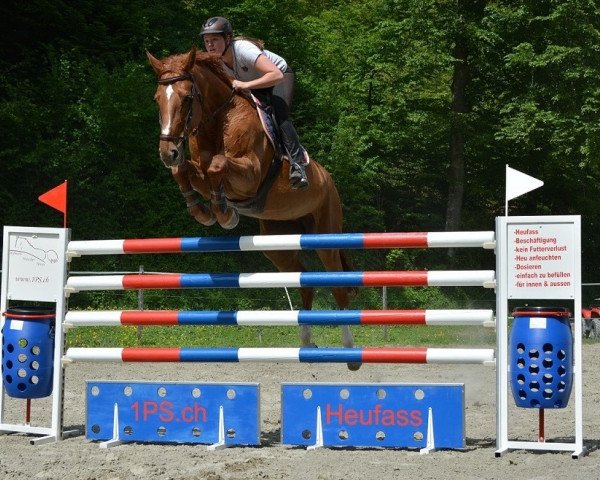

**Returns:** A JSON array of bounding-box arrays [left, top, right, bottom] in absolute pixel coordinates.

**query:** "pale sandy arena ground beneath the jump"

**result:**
[[0, 344, 600, 480]]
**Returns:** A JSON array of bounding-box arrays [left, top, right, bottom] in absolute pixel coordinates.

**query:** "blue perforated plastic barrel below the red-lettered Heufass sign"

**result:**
[[508, 307, 573, 408]]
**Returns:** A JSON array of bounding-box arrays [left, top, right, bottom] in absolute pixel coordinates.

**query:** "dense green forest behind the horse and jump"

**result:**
[[0, 0, 600, 314]]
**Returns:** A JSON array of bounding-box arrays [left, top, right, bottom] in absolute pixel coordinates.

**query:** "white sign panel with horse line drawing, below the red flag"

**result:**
[[4, 227, 65, 302]]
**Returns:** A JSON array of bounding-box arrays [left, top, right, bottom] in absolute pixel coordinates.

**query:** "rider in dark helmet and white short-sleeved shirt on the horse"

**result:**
[[200, 17, 308, 190]]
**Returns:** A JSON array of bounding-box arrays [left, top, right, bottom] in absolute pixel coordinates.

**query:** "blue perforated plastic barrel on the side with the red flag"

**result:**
[[2, 307, 56, 398]]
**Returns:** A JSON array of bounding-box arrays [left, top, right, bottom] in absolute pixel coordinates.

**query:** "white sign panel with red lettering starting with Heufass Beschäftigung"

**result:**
[[507, 223, 578, 300]]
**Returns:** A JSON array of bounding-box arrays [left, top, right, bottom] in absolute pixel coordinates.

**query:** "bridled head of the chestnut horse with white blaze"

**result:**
[[146, 47, 201, 167]]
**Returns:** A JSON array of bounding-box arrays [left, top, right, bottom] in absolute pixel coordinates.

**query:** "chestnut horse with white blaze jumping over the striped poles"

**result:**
[[146, 47, 360, 370]]
